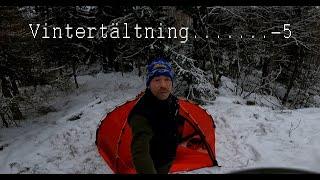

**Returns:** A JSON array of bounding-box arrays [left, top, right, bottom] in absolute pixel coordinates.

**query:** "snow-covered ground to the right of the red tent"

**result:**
[[202, 97, 320, 172]]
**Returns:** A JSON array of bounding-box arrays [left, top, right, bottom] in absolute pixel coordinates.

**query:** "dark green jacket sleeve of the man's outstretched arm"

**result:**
[[129, 115, 157, 174]]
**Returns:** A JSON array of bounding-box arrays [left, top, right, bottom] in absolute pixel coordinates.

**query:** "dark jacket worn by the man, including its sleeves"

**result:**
[[128, 89, 183, 174]]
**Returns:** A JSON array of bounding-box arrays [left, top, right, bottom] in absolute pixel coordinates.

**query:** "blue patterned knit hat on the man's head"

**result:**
[[146, 58, 174, 87]]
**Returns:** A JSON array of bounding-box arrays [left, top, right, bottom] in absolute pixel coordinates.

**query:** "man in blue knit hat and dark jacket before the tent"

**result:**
[[128, 58, 183, 174]]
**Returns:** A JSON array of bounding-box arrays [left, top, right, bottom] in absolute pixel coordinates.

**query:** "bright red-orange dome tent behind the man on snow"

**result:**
[[96, 93, 218, 174]]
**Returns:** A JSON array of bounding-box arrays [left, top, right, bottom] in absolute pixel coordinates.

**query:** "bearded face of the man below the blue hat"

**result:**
[[150, 76, 172, 100]]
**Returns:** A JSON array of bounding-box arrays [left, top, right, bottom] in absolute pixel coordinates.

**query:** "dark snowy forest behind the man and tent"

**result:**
[[0, 6, 320, 127]]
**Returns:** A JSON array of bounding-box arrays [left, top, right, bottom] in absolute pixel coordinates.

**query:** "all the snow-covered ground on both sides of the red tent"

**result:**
[[0, 73, 320, 174]]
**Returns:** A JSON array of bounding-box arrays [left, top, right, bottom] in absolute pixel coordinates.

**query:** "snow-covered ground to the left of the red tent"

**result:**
[[0, 73, 144, 173]]
